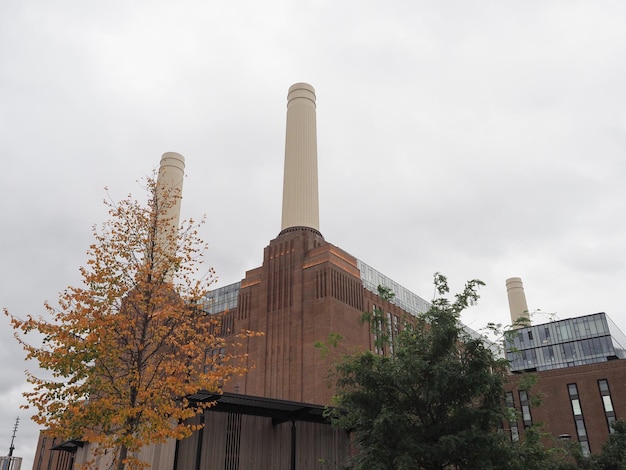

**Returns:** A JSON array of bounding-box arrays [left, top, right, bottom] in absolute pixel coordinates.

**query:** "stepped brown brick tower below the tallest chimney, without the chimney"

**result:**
[[219, 228, 407, 404]]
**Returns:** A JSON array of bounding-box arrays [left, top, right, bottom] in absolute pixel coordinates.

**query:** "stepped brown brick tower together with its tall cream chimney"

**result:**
[[209, 83, 427, 404]]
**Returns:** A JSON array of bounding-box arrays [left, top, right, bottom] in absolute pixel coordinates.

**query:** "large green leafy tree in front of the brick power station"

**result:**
[[329, 274, 509, 470]]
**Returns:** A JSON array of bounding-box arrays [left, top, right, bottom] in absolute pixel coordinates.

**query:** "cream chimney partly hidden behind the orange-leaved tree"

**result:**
[[156, 152, 185, 281]]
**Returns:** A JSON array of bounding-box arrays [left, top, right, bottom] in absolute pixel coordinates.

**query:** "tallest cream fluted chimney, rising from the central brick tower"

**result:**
[[281, 83, 319, 232]]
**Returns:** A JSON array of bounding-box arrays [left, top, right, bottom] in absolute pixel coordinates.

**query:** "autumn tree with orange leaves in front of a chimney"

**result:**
[[5, 173, 253, 470]]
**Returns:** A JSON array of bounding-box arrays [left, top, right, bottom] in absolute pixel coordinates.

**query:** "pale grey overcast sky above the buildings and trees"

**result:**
[[0, 0, 626, 469]]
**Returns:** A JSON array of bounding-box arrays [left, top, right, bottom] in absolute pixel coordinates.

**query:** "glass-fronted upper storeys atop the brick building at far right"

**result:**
[[505, 312, 626, 373]]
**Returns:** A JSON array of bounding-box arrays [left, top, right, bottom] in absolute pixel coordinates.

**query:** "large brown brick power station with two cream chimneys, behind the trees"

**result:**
[[34, 83, 429, 470]]
